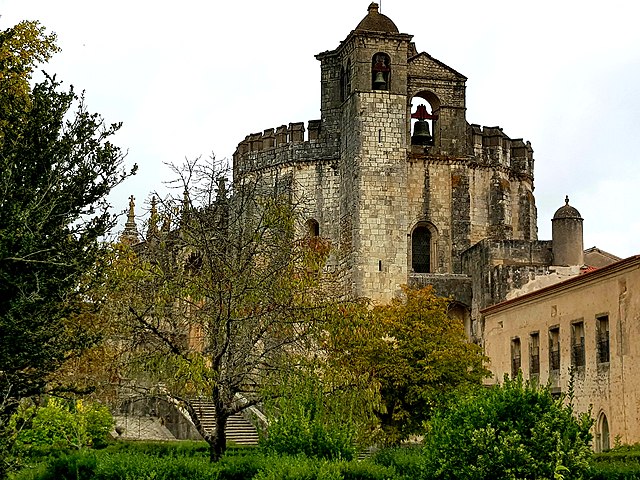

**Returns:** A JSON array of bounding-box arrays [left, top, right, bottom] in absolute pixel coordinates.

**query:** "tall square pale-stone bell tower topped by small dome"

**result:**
[[316, 3, 412, 301]]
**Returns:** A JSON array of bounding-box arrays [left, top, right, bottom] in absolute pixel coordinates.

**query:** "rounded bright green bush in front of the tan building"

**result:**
[[424, 376, 593, 480]]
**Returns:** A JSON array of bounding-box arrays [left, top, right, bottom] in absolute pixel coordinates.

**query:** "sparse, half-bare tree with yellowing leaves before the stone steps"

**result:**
[[114, 160, 340, 461]]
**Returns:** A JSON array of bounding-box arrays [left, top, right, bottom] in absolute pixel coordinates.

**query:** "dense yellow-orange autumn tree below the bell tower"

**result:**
[[327, 286, 488, 443]]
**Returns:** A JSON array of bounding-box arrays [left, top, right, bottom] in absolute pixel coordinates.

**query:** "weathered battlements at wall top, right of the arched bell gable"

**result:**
[[469, 124, 533, 177]]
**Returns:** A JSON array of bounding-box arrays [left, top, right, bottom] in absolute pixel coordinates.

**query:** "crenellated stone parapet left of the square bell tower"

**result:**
[[233, 120, 339, 175]]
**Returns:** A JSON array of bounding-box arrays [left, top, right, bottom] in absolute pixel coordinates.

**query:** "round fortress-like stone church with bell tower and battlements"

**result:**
[[233, 3, 604, 340]]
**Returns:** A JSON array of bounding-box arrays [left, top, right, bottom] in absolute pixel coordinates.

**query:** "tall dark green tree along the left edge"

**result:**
[[0, 22, 133, 476]]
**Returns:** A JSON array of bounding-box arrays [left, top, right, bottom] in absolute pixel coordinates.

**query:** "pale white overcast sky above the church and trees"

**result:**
[[0, 0, 640, 257]]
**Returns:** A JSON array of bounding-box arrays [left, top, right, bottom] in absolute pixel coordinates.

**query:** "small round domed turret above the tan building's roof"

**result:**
[[551, 196, 584, 265]]
